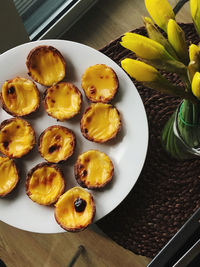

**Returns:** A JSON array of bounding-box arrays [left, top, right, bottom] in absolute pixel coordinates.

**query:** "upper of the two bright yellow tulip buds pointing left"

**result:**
[[120, 32, 186, 74]]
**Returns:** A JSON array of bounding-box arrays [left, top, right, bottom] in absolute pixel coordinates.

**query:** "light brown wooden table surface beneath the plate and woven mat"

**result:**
[[0, 0, 191, 267]]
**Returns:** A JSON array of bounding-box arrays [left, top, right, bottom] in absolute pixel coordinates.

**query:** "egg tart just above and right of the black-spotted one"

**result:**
[[74, 150, 114, 189]]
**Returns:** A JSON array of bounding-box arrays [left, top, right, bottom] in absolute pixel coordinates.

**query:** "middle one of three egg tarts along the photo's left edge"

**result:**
[[0, 118, 36, 158]]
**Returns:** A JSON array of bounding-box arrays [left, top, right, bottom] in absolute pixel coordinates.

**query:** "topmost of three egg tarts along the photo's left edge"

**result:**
[[1, 77, 40, 116]]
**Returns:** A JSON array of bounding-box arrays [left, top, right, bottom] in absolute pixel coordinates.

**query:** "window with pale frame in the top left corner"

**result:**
[[0, 0, 97, 53]]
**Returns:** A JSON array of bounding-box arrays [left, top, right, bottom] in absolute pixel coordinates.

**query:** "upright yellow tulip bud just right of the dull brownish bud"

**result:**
[[167, 19, 189, 65]]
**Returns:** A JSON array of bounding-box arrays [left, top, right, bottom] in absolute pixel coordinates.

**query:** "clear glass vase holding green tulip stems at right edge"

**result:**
[[161, 100, 200, 160]]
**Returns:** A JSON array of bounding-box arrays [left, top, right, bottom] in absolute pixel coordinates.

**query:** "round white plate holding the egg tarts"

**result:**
[[0, 40, 148, 233]]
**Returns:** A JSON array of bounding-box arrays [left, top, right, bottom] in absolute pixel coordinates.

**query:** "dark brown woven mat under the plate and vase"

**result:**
[[97, 24, 200, 258]]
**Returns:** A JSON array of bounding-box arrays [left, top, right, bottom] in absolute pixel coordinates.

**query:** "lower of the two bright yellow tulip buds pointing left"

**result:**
[[121, 58, 191, 99]]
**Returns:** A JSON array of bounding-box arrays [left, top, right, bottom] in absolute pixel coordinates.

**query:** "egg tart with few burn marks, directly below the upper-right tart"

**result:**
[[81, 103, 121, 143]]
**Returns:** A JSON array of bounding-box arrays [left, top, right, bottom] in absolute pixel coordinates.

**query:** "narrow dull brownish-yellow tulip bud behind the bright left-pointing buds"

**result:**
[[143, 17, 177, 59]]
